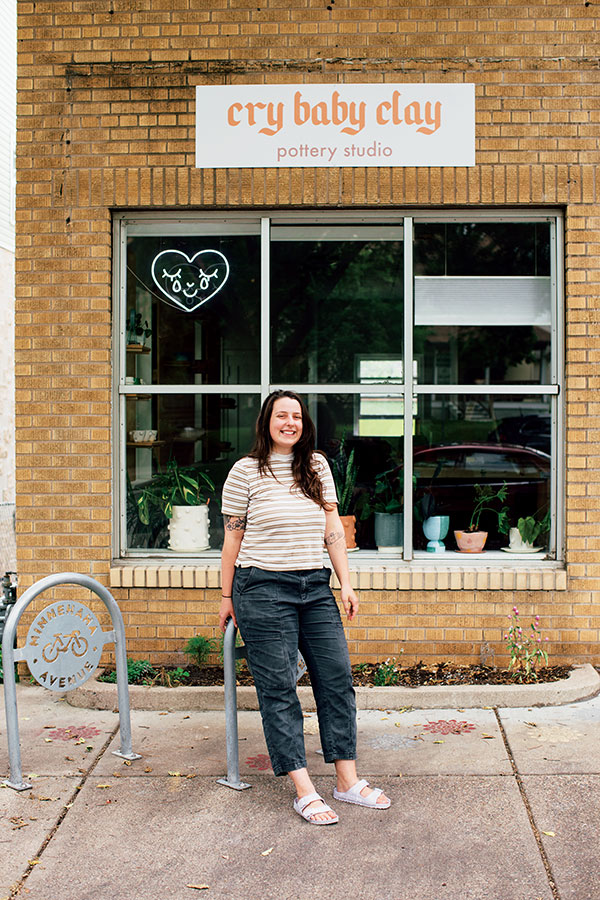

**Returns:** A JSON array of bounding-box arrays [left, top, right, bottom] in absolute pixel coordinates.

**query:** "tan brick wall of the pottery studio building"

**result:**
[[16, 0, 600, 660]]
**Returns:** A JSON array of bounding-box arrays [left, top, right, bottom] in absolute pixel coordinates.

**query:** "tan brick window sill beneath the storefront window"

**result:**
[[110, 551, 567, 591]]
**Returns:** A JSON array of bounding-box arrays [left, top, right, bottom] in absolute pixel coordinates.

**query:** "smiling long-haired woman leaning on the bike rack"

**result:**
[[219, 391, 390, 825]]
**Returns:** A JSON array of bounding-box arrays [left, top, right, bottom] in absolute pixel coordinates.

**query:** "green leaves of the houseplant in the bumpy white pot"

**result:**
[[137, 459, 215, 525]]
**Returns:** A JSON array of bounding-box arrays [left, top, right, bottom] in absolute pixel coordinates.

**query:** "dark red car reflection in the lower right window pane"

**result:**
[[413, 444, 550, 549]]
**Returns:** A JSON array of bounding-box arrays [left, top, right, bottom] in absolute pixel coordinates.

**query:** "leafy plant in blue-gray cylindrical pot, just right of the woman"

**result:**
[[359, 466, 404, 553]]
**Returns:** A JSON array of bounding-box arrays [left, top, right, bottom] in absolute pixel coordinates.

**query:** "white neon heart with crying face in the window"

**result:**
[[152, 250, 229, 312]]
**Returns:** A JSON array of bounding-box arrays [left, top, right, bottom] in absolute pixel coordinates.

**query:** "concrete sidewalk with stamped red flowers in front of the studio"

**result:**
[[0, 685, 600, 900]]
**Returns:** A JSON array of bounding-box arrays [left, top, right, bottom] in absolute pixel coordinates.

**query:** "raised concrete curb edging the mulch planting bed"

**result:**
[[66, 663, 600, 711]]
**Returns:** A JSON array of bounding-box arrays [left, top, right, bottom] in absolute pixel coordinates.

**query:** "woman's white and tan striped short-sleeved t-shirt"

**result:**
[[221, 453, 337, 572]]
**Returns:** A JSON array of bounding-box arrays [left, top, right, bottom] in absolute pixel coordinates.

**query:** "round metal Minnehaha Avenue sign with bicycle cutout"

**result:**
[[23, 602, 104, 691]]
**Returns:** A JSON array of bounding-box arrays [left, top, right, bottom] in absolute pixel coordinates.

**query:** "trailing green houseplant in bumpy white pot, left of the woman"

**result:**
[[137, 459, 215, 553]]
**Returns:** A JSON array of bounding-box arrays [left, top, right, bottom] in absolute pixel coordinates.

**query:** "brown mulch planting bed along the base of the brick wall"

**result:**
[[105, 662, 572, 687]]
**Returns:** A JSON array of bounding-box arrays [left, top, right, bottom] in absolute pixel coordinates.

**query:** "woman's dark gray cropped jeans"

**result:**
[[232, 566, 356, 775]]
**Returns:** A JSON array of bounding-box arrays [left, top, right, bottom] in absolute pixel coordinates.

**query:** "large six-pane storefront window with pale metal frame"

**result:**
[[115, 211, 562, 565]]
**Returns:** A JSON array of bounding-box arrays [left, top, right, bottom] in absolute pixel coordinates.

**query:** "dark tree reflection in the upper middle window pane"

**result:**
[[271, 241, 403, 383]]
